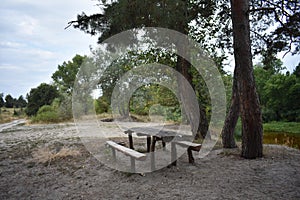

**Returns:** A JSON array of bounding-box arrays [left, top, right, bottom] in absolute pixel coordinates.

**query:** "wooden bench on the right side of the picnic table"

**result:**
[[171, 141, 201, 166]]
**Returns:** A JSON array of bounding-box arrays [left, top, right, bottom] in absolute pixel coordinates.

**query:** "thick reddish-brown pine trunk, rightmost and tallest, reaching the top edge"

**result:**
[[231, 0, 263, 159]]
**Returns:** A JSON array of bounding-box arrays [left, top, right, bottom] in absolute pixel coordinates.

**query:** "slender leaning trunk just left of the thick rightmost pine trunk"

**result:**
[[222, 68, 240, 148]]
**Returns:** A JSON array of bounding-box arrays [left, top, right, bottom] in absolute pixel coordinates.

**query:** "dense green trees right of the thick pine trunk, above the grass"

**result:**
[[254, 58, 300, 122]]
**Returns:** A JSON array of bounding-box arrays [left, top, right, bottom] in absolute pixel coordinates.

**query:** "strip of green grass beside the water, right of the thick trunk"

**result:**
[[263, 122, 300, 134]]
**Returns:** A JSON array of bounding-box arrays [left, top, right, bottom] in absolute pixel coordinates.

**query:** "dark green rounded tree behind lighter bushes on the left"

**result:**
[[25, 83, 59, 116]]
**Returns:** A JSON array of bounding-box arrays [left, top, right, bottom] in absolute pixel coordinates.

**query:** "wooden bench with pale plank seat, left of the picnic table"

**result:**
[[106, 141, 146, 173]]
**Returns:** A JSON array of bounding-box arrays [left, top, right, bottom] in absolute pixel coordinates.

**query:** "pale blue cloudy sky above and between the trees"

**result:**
[[0, 0, 299, 98]]
